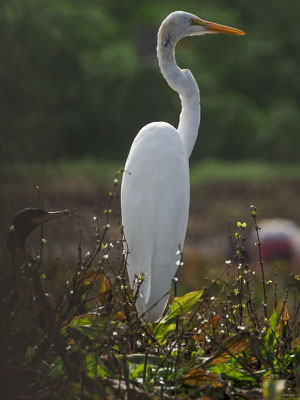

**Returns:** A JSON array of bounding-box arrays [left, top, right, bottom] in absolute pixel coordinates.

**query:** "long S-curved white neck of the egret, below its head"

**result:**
[[157, 25, 200, 157]]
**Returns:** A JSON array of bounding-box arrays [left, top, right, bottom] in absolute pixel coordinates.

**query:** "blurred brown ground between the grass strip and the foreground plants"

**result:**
[[0, 182, 300, 270]]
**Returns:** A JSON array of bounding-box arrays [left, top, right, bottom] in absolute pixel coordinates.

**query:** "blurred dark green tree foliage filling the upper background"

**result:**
[[0, 0, 300, 162]]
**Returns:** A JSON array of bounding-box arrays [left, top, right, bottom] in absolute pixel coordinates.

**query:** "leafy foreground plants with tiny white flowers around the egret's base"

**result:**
[[0, 192, 300, 400]]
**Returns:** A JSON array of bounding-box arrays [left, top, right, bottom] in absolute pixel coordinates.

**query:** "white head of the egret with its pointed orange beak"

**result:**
[[158, 11, 245, 45]]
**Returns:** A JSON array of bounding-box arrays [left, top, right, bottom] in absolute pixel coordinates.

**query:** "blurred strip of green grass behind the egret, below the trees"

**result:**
[[0, 158, 300, 193]]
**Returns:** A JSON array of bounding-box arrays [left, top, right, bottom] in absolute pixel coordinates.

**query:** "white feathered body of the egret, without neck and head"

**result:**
[[121, 122, 190, 321]]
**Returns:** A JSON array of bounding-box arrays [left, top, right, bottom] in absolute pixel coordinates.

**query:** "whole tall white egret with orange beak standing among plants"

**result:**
[[121, 11, 245, 322]]
